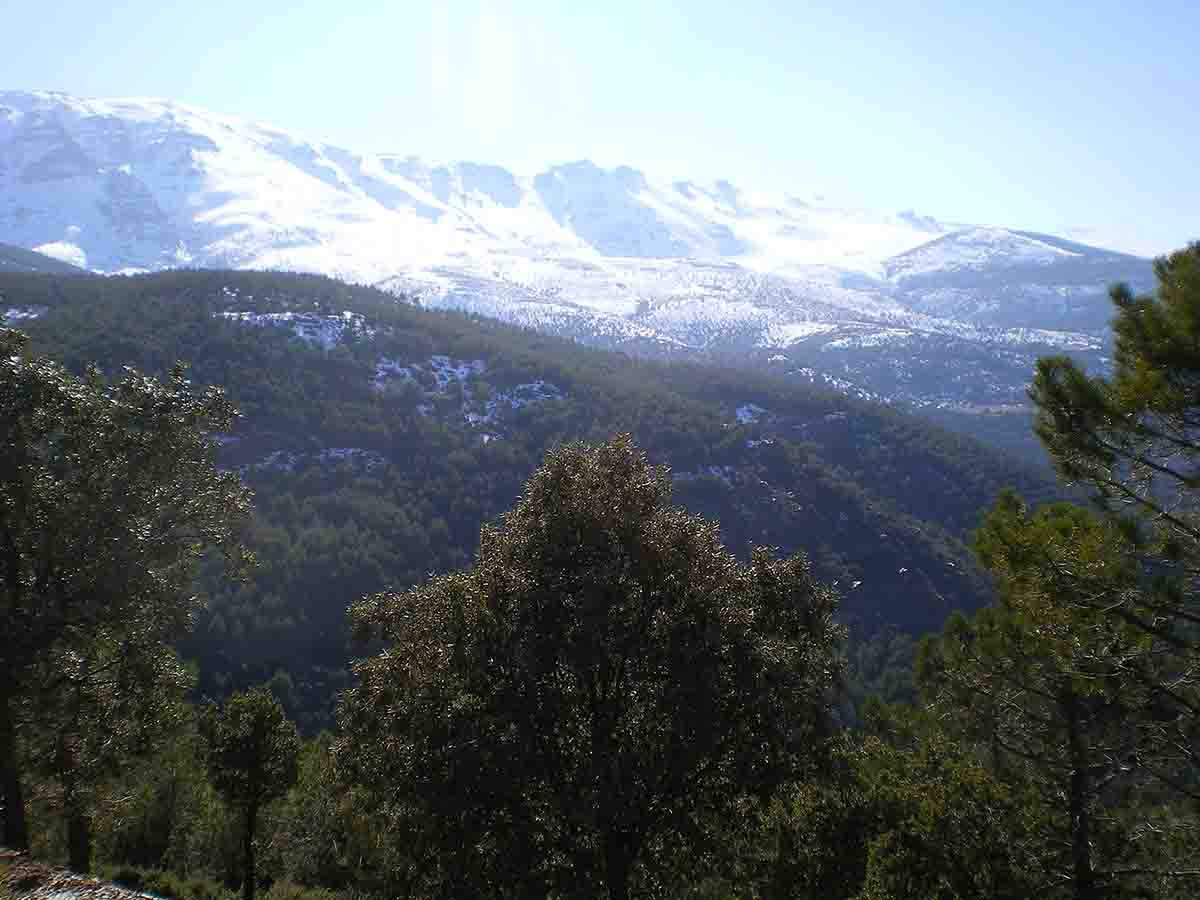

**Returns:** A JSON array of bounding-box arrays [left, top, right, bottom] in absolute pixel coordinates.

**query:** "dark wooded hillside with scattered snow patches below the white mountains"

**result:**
[[0, 271, 1050, 722]]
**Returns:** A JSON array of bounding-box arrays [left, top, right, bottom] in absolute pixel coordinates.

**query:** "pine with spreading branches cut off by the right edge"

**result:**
[[1031, 244, 1200, 800]]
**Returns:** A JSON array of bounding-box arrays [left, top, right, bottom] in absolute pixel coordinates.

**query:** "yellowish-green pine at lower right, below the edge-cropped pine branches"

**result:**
[[918, 494, 1196, 900]]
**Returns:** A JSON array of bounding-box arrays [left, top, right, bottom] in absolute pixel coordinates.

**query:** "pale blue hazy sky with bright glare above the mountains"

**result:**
[[0, 0, 1200, 252]]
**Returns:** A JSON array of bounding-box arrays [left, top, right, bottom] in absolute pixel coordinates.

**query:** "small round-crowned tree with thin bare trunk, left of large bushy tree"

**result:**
[[200, 688, 300, 900]]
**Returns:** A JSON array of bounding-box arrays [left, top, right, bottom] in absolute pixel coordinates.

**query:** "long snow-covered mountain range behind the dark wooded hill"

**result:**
[[0, 92, 1150, 420]]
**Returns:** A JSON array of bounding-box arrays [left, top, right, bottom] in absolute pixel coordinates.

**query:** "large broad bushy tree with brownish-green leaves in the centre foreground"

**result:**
[[336, 437, 841, 900]]
